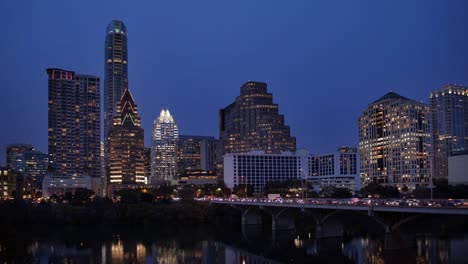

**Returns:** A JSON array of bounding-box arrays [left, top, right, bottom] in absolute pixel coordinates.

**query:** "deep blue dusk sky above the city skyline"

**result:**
[[0, 0, 468, 164]]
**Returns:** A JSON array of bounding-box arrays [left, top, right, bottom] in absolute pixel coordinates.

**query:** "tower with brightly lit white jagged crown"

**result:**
[[151, 109, 179, 182]]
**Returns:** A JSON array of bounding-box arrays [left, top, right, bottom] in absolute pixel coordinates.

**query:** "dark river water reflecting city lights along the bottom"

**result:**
[[0, 220, 468, 264]]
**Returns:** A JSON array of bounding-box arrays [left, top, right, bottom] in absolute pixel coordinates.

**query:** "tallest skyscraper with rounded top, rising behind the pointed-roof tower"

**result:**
[[104, 20, 128, 138]]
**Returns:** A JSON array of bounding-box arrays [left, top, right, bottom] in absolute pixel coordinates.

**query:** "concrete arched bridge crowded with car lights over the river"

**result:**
[[209, 198, 468, 236]]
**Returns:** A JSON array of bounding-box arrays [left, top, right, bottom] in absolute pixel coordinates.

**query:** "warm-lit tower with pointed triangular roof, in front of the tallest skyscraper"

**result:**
[[107, 89, 145, 185]]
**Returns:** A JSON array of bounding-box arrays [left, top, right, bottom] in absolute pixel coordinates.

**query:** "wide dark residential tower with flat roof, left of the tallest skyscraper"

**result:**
[[47, 68, 101, 177]]
